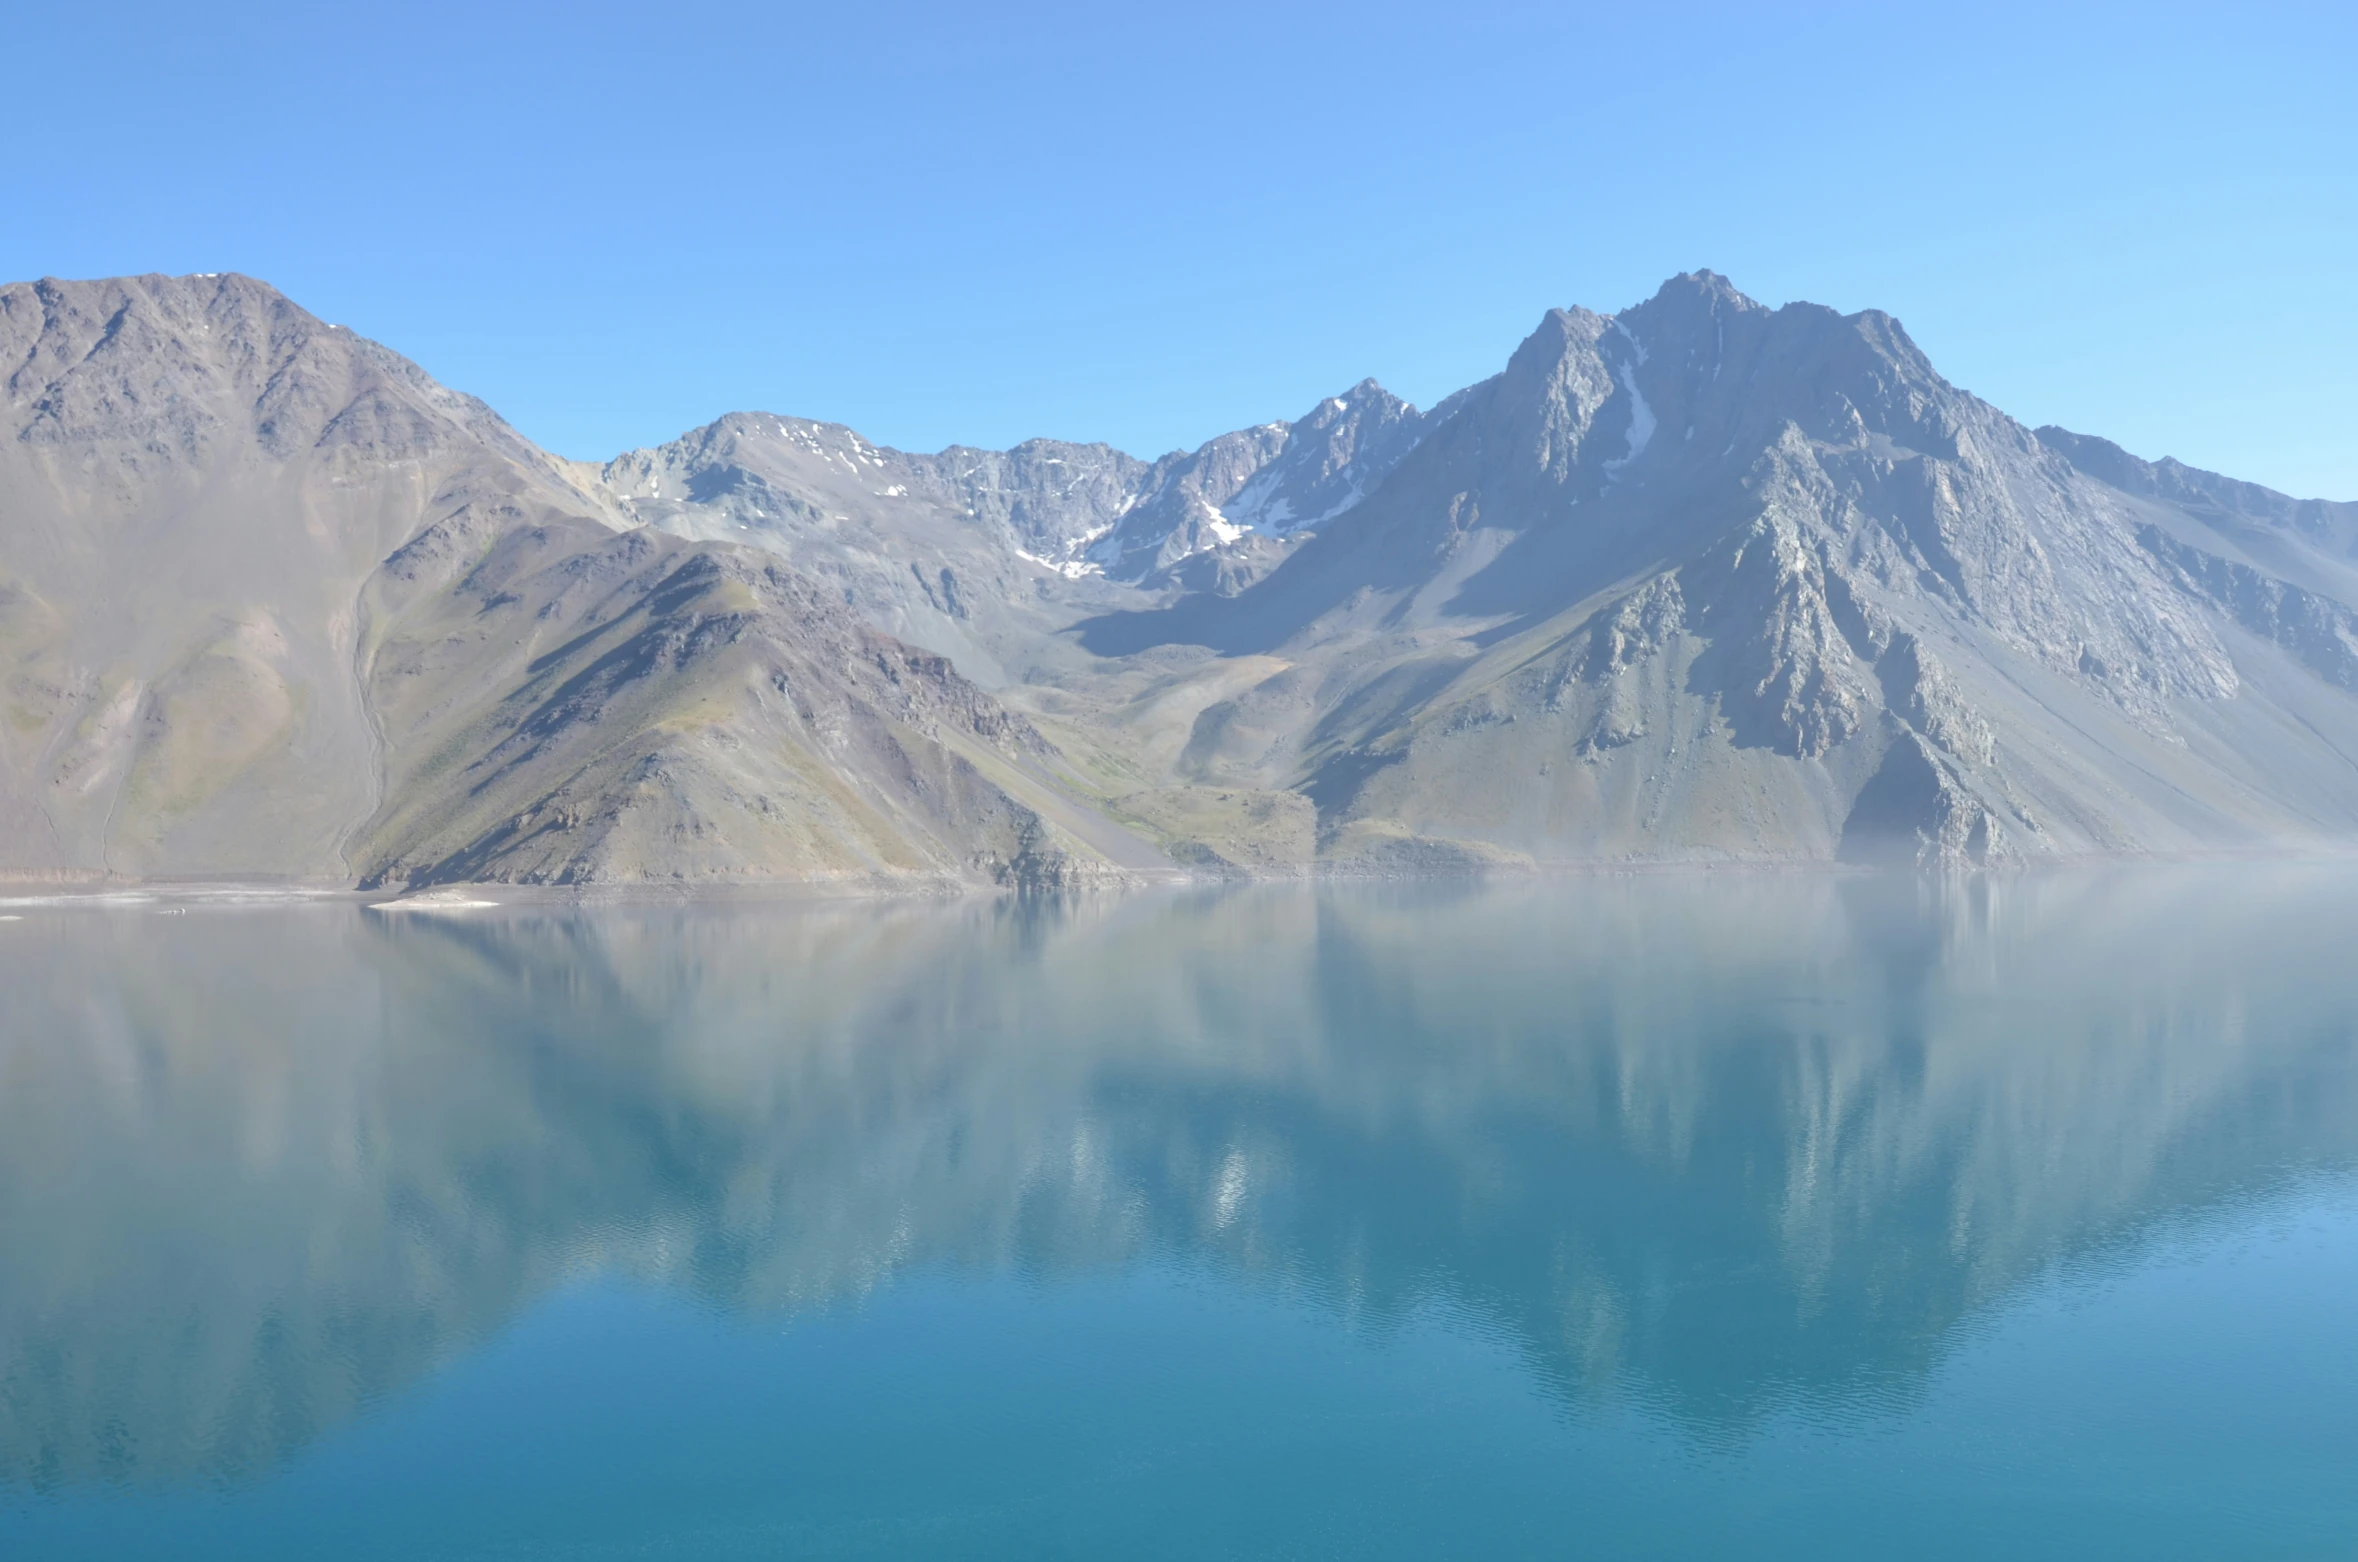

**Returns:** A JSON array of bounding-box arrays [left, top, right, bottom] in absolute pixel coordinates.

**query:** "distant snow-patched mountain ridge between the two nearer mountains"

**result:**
[[599, 380, 1448, 687]]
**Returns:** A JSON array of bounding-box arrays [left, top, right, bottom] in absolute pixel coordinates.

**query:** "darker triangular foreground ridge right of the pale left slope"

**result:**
[[356, 521, 1160, 887]]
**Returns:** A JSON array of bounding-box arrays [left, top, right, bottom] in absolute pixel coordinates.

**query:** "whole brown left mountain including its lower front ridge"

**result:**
[[0, 276, 1160, 882]]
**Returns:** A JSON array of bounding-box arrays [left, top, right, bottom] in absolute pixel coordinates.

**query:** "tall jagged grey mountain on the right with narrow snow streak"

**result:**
[[1056, 274, 2358, 861]]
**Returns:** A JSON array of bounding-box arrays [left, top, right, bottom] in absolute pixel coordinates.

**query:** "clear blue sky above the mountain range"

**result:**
[[0, 0, 2358, 498]]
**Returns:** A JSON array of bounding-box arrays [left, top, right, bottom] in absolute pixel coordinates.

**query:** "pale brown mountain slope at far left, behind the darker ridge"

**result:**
[[0, 276, 617, 875]]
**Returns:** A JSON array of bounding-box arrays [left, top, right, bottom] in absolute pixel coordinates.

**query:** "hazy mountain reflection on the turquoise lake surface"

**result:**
[[0, 866, 2358, 1489]]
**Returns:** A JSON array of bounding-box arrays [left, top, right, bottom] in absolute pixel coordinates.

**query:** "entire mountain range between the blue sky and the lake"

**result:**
[[0, 271, 2358, 887]]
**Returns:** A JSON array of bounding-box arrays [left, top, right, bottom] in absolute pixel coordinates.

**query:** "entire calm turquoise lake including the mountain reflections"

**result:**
[[0, 866, 2358, 1562]]
